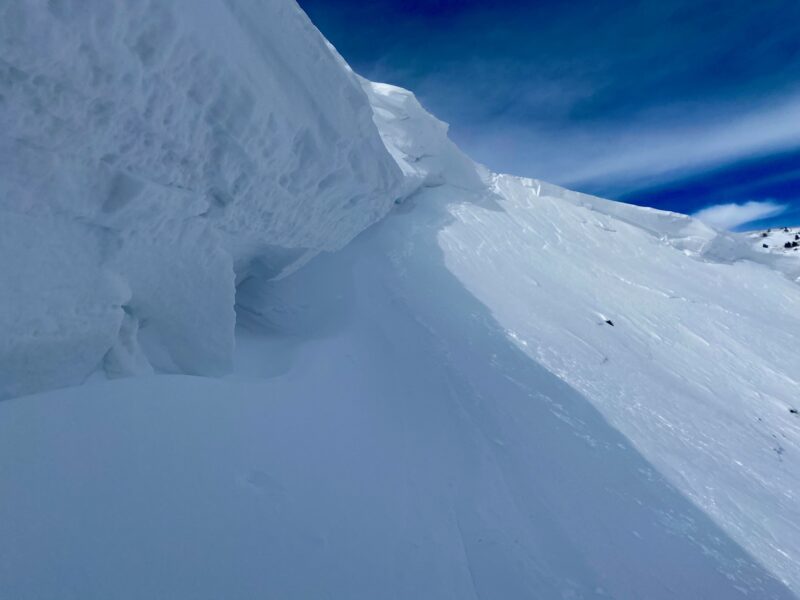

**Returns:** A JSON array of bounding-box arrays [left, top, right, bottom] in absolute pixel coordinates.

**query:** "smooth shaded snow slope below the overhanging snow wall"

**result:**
[[0, 210, 791, 599]]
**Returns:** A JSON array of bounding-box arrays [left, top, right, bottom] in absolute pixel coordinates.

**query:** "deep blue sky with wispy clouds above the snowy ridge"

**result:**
[[300, 0, 800, 228]]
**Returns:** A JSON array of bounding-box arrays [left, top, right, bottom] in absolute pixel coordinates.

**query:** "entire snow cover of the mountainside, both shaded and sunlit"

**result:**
[[0, 0, 800, 600]]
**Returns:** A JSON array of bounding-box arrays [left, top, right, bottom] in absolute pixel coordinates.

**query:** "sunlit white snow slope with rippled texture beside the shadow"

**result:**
[[439, 176, 800, 586]]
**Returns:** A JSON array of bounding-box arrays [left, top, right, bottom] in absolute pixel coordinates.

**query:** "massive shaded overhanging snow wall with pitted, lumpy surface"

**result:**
[[0, 0, 400, 397]]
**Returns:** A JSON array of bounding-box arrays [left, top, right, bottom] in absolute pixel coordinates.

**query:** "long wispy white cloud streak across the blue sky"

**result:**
[[453, 94, 800, 196]]
